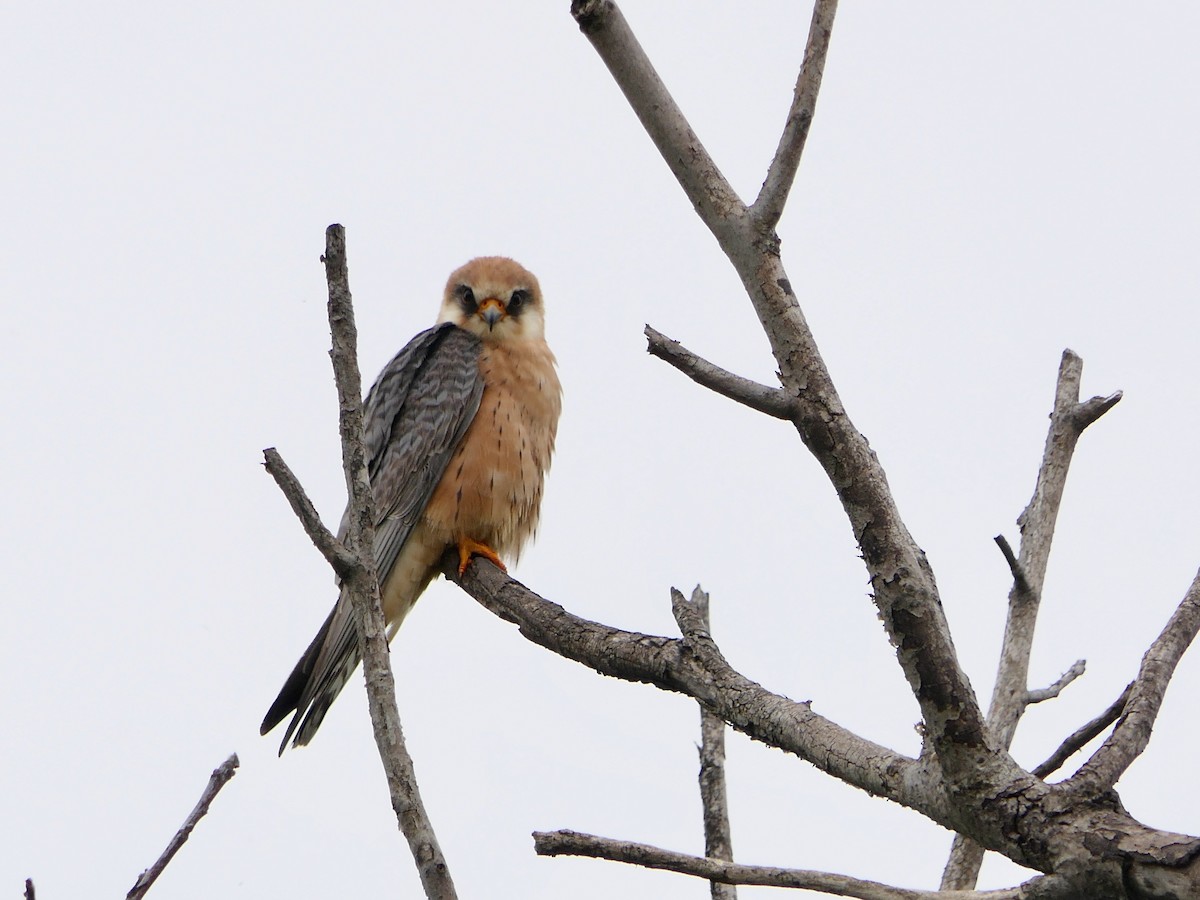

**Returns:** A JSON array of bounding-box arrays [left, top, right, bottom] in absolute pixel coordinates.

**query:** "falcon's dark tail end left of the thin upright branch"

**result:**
[[259, 595, 360, 756]]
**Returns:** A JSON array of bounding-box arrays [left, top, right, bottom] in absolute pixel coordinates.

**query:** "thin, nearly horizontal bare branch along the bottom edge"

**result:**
[[533, 830, 1054, 900]]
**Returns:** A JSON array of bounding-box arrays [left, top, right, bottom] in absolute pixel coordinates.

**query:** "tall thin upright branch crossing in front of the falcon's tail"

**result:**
[[322, 224, 457, 900]]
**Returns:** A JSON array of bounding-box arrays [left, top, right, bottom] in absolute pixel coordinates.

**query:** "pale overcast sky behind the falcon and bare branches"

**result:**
[[0, 0, 1200, 900]]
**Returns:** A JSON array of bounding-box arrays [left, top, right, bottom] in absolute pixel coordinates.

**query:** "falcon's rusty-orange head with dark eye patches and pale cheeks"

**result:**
[[438, 257, 545, 341]]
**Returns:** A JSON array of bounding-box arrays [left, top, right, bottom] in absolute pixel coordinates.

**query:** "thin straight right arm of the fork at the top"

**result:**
[[750, 0, 838, 230]]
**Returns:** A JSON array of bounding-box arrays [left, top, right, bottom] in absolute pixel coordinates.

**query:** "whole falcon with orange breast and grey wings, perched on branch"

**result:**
[[262, 257, 562, 754]]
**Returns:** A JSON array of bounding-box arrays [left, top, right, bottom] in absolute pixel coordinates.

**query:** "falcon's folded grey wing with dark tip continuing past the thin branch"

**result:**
[[262, 323, 484, 754]]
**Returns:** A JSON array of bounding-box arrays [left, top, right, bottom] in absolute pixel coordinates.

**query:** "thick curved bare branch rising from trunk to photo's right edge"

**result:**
[[1058, 572, 1200, 797]]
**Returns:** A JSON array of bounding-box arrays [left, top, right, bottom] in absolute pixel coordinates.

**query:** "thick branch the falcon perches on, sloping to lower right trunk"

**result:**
[[453, 564, 1200, 900]]
